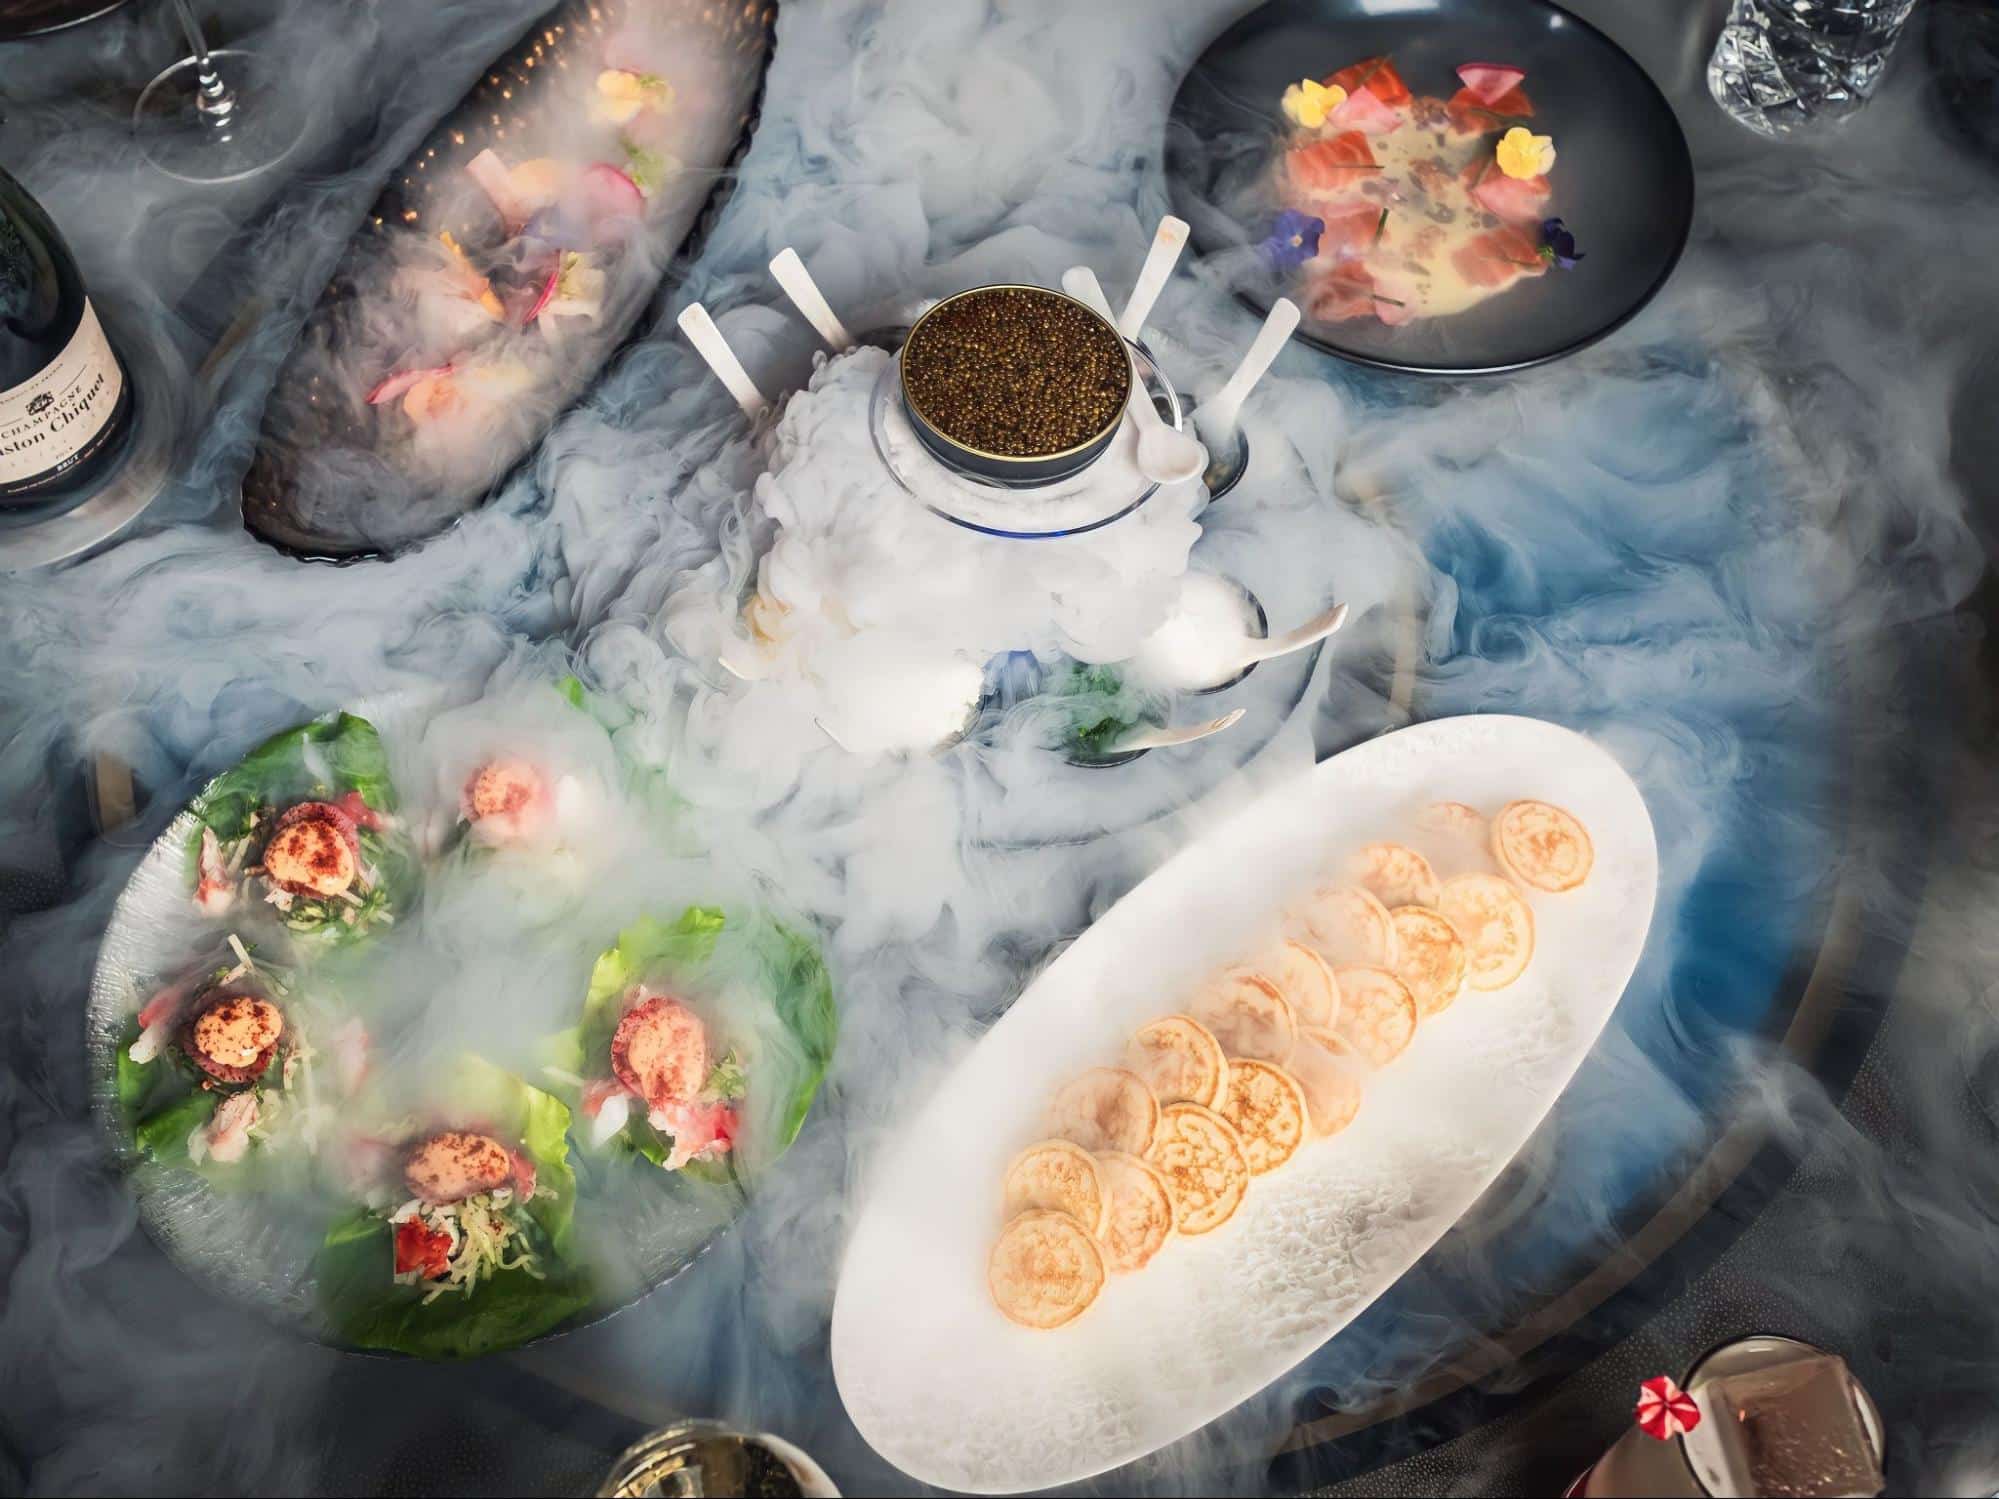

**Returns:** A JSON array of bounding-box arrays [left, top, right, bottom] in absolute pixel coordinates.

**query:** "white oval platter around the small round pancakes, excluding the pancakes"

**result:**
[[832, 716, 1659, 1493]]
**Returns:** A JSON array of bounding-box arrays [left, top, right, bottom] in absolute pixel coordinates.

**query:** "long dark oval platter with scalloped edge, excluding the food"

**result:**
[[244, 0, 776, 562]]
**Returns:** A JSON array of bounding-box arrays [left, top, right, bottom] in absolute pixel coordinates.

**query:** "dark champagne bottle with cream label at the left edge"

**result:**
[[0, 170, 132, 506]]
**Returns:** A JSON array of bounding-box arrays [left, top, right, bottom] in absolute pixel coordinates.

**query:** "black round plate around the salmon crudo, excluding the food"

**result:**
[[1165, 0, 1693, 374]]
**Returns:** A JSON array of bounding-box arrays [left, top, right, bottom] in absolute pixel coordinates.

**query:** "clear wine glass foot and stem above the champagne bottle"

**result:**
[[132, 0, 304, 182]]
